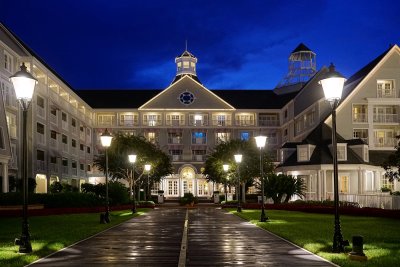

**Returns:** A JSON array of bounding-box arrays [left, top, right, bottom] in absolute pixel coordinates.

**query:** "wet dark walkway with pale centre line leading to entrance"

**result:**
[[30, 207, 334, 267]]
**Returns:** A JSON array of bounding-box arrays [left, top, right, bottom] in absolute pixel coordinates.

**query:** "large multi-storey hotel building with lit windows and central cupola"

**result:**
[[0, 24, 400, 208]]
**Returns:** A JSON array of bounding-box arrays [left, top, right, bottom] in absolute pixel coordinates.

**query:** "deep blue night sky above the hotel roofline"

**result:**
[[0, 0, 400, 89]]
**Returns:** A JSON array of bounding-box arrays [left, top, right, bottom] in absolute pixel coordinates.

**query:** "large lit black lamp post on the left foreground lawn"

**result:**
[[10, 63, 37, 253]]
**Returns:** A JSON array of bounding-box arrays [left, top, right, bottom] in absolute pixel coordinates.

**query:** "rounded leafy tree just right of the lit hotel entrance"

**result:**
[[204, 140, 273, 202]]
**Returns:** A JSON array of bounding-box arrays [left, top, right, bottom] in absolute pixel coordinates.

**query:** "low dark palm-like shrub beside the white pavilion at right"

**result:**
[[264, 173, 306, 204]]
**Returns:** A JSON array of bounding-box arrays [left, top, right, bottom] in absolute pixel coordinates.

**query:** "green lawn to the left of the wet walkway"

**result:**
[[0, 209, 148, 267]]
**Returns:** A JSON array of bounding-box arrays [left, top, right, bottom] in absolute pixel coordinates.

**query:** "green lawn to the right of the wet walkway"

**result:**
[[230, 209, 400, 267]]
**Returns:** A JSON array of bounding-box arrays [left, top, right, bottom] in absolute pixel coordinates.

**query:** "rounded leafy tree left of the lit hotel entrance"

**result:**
[[94, 133, 172, 201]]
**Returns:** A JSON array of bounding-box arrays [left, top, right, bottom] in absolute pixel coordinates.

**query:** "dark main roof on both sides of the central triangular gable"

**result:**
[[75, 90, 296, 109]]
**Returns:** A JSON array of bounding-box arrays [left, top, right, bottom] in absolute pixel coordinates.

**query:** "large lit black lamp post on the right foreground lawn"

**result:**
[[319, 63, 348, 253]]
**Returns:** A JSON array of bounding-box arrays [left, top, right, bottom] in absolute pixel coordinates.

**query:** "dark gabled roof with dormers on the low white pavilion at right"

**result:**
[[279, 123, 365, 167]]
